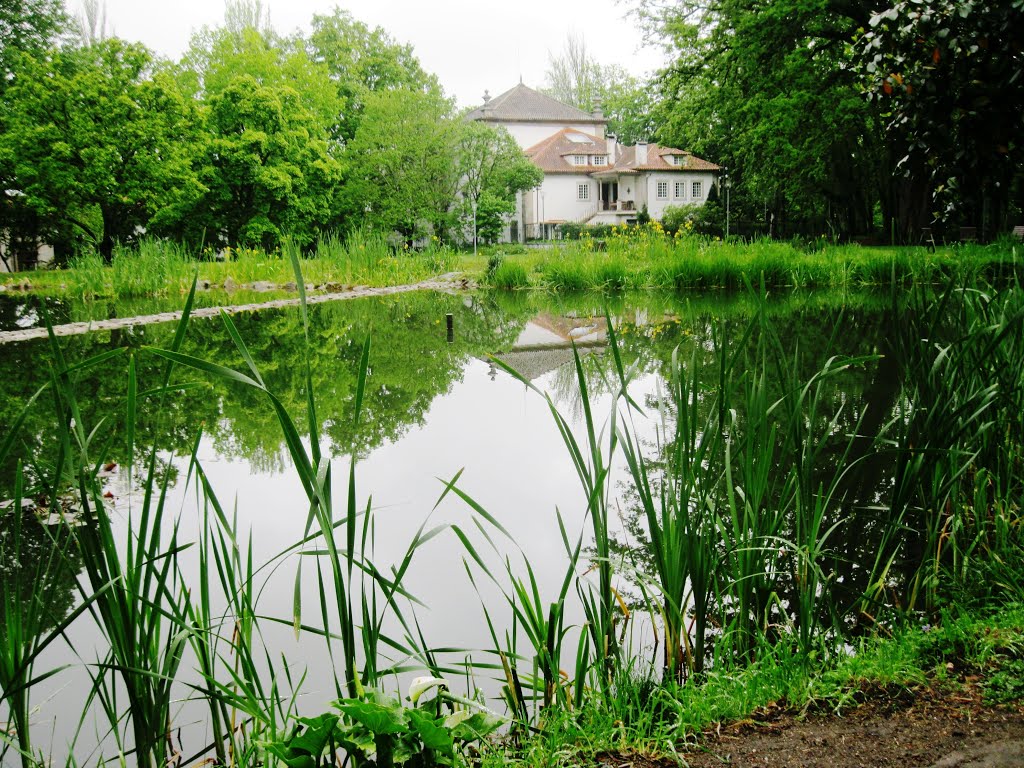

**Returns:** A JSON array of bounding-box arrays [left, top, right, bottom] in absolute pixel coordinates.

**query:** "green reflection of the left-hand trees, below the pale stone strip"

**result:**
[[0, 294, 525, 498]]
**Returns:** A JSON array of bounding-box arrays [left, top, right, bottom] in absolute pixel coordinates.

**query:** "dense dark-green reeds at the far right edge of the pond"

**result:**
[[867, 278, 1024, 610]]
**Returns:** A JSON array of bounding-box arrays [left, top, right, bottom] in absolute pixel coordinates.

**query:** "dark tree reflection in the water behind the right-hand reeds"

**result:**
[[602, 306, 901, 643]]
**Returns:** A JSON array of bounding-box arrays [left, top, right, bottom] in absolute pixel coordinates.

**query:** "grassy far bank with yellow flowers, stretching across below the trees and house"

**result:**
[[0, 228, 1022, 301]]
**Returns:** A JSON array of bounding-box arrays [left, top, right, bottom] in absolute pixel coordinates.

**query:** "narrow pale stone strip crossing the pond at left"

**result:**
[[0, 272, 466, 344]]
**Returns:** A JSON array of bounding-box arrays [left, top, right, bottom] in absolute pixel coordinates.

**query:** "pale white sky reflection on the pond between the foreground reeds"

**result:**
[[34, 327, 656, 755]]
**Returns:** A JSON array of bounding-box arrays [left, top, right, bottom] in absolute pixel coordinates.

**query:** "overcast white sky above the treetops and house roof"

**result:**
[[79, 0, 663, 106]]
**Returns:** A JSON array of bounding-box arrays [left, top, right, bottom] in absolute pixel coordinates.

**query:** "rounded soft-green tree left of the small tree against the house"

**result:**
[[342, 90, 461, 241]]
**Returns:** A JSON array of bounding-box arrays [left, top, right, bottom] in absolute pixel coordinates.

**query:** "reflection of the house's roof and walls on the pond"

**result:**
[[488, 312, 608, 381]]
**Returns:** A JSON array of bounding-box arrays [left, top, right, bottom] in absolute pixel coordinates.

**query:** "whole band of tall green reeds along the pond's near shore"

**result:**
[[0, 257, 1024, 766]]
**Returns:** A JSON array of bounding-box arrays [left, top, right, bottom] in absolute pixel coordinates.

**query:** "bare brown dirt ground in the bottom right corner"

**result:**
[[599, 685, 1024, 768]]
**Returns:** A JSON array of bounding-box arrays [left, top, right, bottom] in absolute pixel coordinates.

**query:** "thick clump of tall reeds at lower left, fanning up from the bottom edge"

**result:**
[[37, 288, 193, 766]]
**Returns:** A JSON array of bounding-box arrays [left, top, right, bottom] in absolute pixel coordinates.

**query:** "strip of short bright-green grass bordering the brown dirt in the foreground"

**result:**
[[516, 604, 1024, 766]]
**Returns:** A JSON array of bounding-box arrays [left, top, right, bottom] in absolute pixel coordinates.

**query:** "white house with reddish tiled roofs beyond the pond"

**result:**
[[468, 83, 719, 241]]
